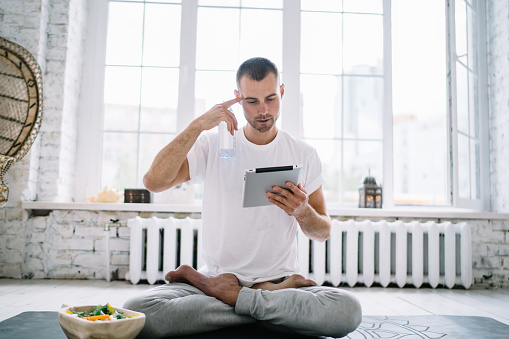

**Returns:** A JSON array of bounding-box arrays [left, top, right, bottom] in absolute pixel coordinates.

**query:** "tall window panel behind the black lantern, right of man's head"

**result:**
[[300, 1, 384, 206]]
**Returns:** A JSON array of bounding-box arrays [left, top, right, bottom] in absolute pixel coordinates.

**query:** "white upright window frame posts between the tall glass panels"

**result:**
[[75, 0, 490, 211]]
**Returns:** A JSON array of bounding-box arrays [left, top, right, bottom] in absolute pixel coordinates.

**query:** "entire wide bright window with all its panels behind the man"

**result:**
[[77, 0, 489, 208]]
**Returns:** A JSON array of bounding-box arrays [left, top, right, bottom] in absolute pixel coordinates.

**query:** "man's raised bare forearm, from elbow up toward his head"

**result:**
[[143, 121, 202, 192]]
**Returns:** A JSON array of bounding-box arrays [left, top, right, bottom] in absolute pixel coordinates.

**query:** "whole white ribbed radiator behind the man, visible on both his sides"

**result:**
[[127, 217, 472, 288]]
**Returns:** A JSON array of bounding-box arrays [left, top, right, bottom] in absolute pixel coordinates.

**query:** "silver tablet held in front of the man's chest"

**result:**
[[242, 165, 301, 207]]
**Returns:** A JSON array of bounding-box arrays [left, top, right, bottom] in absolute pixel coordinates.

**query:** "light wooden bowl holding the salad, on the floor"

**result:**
[[58, 305, 145, 339]]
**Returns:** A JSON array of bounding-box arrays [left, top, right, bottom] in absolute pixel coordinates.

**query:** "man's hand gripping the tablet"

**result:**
[[267, 181, 309, 218]]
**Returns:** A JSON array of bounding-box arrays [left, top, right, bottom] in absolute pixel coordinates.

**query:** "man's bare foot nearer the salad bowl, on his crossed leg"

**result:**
[[164, 265, 242, 306]]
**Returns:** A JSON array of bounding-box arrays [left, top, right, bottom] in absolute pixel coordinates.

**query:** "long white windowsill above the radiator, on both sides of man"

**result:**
[[21, 201, 509, 220]]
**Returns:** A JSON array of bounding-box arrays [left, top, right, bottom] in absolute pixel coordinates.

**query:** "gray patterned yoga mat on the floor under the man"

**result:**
[[0, 312, 509, 339]]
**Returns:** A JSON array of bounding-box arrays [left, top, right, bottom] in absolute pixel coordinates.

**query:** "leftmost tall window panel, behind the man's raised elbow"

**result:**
[[101, 1, 181, 194]]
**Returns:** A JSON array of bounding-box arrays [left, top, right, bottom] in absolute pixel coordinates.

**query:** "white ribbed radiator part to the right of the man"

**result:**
[[298, 220, 472, 288]]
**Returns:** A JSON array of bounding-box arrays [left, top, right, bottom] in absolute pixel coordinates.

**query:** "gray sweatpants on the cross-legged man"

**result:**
[[124, 283, 362, 338]]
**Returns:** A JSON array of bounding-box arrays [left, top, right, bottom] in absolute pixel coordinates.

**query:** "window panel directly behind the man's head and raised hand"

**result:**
[[195, 0, 284, 131]]
